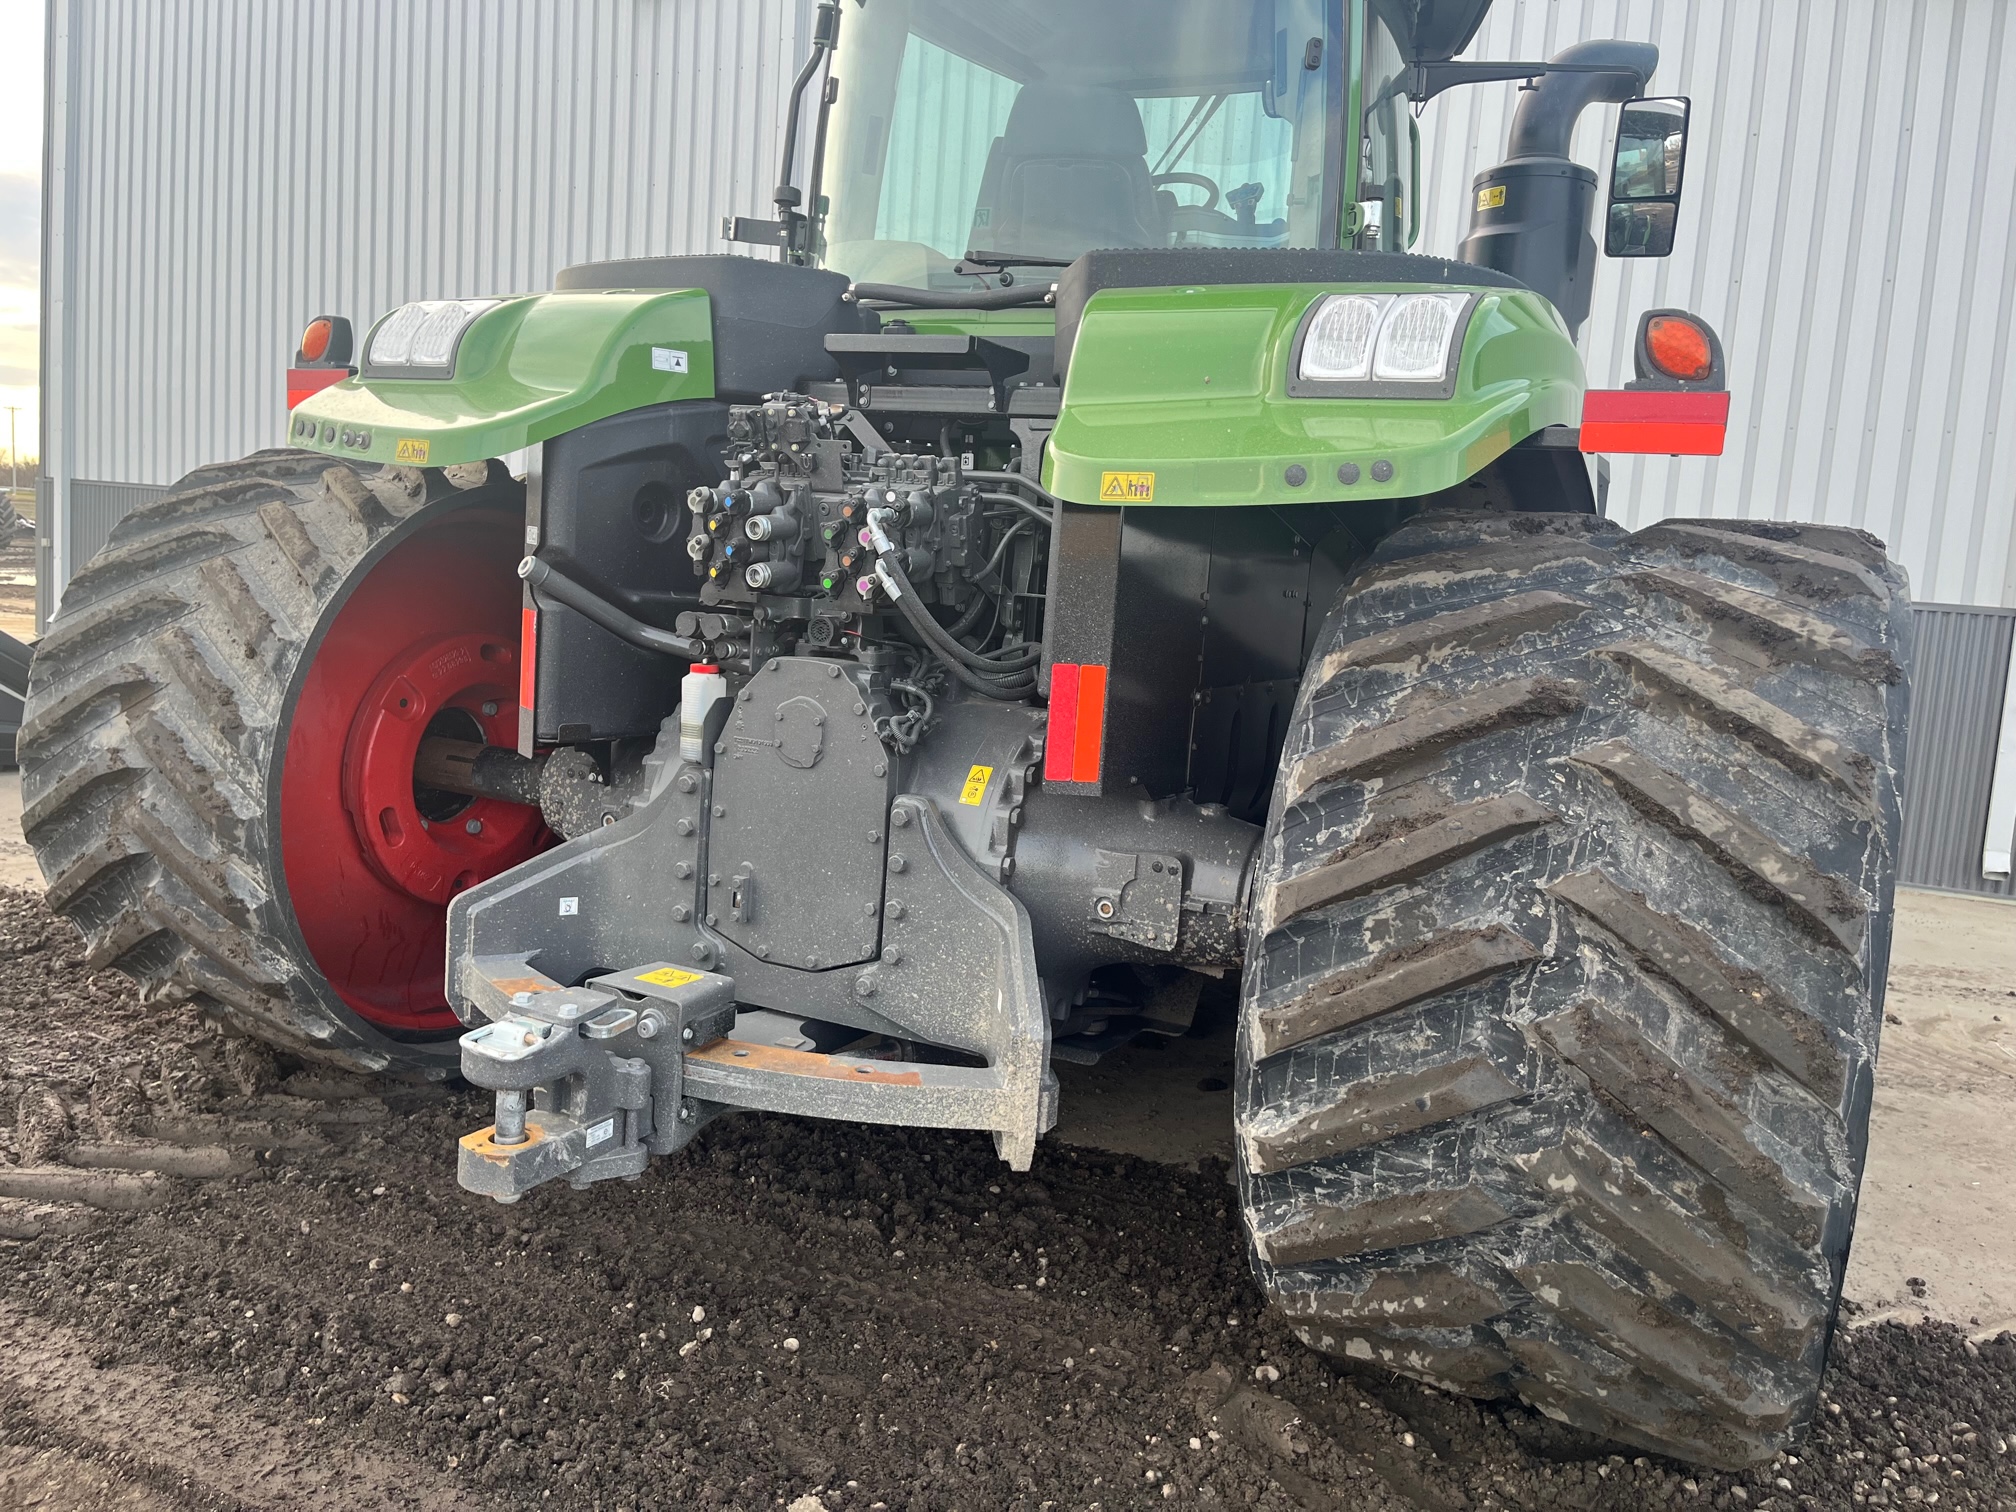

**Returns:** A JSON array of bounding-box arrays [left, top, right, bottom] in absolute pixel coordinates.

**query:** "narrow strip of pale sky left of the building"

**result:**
[[0, 0, 42, 473]]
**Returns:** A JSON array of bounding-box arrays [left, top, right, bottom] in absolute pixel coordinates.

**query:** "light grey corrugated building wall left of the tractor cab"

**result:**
[[42, 0, 812, 604]]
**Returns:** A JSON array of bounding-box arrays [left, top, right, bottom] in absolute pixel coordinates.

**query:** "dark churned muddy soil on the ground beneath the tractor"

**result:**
[[0, 891, 2016, 1512]]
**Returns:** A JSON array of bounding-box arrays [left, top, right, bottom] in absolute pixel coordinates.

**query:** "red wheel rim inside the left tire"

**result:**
[[280, 510, 552, 1032]]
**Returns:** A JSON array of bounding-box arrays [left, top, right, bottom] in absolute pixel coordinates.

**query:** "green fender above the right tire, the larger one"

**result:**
[[1044, 284, 1585, 504]]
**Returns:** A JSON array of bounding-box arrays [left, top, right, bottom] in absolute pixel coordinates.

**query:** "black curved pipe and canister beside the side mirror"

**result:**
[[1456, 42, 1659, 337]]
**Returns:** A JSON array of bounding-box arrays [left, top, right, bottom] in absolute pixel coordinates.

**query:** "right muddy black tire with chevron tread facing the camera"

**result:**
[[1238, 516, 1909, 1468]]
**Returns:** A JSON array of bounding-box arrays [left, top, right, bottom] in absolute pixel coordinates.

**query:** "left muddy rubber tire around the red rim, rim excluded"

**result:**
[[20, 452, 524, 1077]]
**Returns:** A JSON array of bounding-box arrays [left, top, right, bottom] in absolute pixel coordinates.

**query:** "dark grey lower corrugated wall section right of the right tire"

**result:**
[[1897, 605, 2016, 897]]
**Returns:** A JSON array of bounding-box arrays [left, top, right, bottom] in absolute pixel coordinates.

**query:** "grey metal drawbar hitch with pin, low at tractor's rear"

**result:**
[[458, 958, 736, 1202]]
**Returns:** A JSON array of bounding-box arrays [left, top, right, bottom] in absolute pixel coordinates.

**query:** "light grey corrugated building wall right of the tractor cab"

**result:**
[[1419, 0, 2016, 607]]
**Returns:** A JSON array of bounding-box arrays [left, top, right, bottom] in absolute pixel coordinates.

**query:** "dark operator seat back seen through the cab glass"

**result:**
[[968, 83, 1169, 258]]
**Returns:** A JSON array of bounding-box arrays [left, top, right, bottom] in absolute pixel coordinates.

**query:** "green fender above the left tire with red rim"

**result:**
[[288, 288, 714, 468]]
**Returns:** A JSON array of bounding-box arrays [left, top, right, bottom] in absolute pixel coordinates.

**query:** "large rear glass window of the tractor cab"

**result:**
[[816, 0, 1345, 288]]
